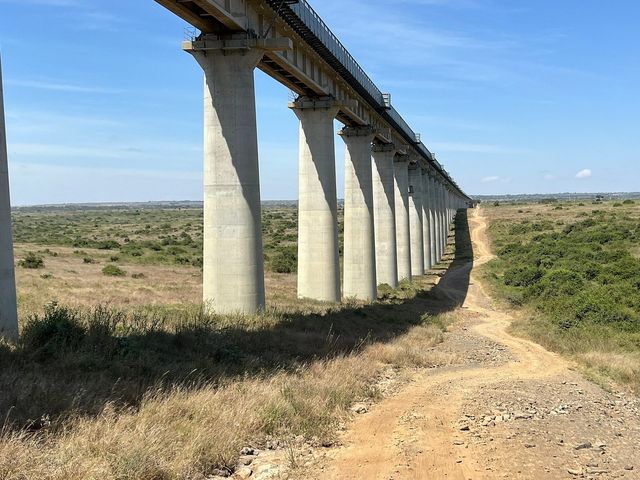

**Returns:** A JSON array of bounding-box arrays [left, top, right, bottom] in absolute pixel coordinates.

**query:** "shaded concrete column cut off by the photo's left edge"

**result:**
[[0, 59, 18, 341]]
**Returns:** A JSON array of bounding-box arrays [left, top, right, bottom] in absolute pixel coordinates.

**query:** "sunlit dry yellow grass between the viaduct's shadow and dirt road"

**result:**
[[0, 314, 462, 480]]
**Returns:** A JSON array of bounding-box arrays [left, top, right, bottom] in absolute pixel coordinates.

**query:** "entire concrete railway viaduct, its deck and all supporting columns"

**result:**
[[0, 0, 472, 338]]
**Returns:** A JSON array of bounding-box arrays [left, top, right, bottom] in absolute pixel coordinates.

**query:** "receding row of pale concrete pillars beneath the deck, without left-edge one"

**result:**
[[185, 39, 462, 313]]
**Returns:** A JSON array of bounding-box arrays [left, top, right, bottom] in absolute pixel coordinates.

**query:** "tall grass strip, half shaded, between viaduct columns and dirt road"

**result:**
[[0, 287, 460, 479]]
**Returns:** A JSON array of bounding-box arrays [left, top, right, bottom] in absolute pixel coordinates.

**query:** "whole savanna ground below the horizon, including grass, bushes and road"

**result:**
[[0, 201, 640, 480]]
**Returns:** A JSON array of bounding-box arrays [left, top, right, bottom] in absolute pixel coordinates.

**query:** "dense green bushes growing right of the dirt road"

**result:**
[[495, 211, 640, 332]]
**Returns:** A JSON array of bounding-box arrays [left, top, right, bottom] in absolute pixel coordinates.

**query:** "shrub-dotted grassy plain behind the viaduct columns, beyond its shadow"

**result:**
[[13, 206, 342, 317]]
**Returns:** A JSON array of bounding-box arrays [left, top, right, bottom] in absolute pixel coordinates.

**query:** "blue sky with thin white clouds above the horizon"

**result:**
[[0, 0, 640, 205]]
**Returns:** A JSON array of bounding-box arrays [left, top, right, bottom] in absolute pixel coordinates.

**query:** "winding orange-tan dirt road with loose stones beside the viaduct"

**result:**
[[310, 210, 640, 480]]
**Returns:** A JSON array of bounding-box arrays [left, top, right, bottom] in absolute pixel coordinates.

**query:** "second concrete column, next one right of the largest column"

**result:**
[[289, 98, 341, 302]]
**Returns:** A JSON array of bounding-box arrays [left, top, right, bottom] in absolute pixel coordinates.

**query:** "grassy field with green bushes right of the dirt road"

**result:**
[[483, 200, 640, 391]]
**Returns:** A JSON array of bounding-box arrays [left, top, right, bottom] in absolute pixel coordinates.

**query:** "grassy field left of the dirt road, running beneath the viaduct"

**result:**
[[0, 207, 471, 480]]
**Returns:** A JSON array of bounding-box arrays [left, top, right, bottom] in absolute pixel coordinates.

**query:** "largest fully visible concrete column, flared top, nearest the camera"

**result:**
[[183, 40, 265, 313]]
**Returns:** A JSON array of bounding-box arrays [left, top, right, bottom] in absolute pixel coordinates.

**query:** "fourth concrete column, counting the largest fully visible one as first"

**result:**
[[372, 144, 398, 288]]
